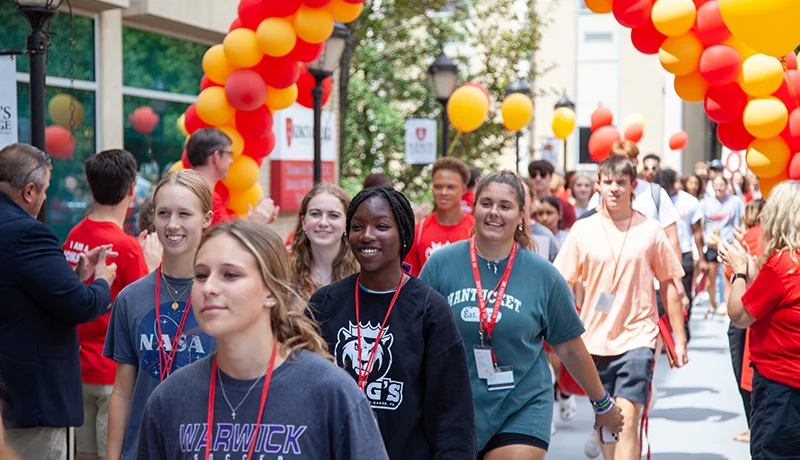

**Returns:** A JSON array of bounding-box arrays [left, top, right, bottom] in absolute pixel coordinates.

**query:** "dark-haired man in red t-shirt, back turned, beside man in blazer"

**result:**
[[63, 149, 153, 459]]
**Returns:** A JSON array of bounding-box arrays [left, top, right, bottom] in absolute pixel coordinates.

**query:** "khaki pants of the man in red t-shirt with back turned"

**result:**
[[75, 383, 114, 457]]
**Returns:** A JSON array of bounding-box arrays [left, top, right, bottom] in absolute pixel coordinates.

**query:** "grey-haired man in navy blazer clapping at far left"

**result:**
[[0, 144, 117, 460]]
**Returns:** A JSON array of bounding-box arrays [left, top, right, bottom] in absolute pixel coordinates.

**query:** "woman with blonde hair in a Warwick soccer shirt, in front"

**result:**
[[139, 221, 386, 460]]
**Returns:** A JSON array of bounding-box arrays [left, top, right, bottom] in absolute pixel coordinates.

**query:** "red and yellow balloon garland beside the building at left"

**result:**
[[174, 0, 365, 216]]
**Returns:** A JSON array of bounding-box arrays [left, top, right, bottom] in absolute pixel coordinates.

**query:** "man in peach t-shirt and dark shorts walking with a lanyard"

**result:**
[[553, 156, 686, 460]]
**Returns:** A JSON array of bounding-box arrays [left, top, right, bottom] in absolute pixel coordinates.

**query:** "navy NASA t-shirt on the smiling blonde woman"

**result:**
[[103, 270, 216, 460]]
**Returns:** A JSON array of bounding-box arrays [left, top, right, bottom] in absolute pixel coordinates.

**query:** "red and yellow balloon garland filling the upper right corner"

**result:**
[[586, 0, 800, 192]]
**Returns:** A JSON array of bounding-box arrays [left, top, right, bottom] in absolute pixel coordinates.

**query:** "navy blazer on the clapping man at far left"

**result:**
[[0, 193, 111, 428]]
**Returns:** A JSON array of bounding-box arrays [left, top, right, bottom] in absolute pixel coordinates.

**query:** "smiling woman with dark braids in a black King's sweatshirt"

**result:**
[[309, 187, 475, 460]]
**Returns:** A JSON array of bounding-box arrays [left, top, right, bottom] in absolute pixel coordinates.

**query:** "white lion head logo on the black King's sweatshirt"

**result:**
[[334, 323, 394, 381]]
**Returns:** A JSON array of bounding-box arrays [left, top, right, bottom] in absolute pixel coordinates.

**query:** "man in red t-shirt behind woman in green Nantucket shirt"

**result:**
[[405, 157, 475, 276]]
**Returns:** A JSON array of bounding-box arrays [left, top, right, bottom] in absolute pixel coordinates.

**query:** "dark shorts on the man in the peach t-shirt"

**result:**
[[592, 348, 655, 404]]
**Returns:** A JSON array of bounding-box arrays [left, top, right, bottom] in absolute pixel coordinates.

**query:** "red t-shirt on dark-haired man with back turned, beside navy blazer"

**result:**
[[63, 217, 149, 385]]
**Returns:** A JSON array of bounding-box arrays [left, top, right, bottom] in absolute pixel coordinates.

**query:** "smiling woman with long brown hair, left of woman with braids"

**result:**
[[292, 183, 358, 299]]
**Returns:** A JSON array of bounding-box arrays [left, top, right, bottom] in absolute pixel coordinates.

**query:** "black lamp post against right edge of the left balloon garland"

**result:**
[[308, 22, 350, 184]]
